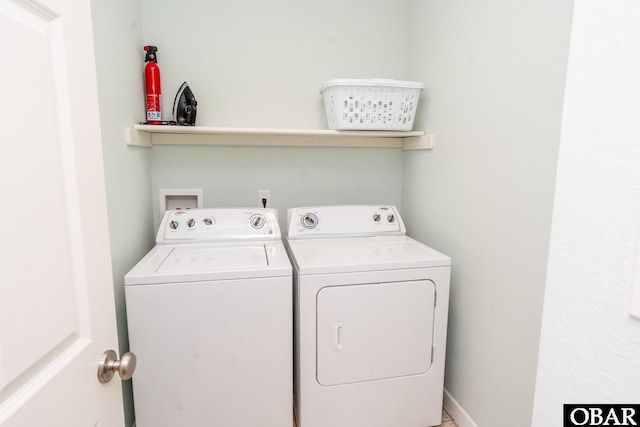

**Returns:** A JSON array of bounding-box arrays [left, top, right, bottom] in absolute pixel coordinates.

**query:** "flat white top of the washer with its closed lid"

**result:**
[[124, 241, 291, 285]]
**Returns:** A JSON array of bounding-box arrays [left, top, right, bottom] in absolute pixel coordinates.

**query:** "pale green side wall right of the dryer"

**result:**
[[402, 0, 573, 427]]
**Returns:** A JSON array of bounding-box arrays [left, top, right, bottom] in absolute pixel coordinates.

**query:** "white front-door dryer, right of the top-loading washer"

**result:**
[[286, 206, 451, 427]]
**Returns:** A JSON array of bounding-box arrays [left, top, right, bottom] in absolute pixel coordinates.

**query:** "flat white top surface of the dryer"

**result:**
[[287, 236, 451, 274]]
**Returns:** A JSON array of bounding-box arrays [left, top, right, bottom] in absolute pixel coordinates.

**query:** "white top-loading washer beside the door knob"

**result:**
[[125, 209, 293, 427]]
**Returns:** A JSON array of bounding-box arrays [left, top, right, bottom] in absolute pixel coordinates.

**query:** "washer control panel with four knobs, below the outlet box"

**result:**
[[156, 208, 280, 244]]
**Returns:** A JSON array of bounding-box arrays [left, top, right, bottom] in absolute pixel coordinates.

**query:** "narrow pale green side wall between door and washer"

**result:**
[[90, 0, 153, 426]]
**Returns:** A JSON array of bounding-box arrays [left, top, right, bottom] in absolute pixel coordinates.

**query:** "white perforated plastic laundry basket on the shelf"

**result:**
[[320, 79, 424, 131]]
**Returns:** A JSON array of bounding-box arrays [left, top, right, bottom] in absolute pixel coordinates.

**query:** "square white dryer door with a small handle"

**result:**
[[316, 280, 435, 386]]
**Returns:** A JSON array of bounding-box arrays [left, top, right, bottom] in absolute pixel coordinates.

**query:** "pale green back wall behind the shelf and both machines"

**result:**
[[142, 0, 409, 225]]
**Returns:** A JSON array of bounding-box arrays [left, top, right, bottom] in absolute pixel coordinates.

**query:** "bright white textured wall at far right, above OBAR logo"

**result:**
[[533, 0, 640, 427]]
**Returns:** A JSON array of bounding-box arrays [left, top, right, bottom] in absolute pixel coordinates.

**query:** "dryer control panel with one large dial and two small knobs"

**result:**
[[287, 205, 406, 239]]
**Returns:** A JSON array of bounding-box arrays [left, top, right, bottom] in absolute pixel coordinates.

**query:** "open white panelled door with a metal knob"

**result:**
[[0, 0, 124, 427]]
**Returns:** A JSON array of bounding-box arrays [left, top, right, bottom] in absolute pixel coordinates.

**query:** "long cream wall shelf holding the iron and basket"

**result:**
[[125, 124, 433, 150]]
